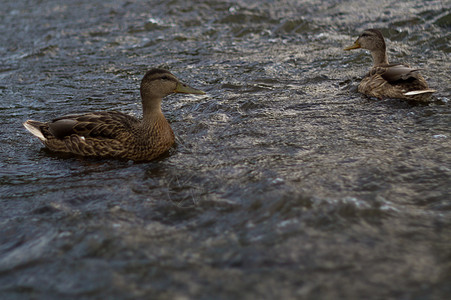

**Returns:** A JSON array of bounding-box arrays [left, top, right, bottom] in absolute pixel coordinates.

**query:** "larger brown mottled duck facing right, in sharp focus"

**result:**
[[23, 69, 205, 161]]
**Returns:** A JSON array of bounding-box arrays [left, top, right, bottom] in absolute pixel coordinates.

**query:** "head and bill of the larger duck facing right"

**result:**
[[141, 68, 205, 99]]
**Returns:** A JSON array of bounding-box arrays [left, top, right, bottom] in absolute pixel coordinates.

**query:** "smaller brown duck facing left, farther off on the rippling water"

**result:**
[[344, 29, 435, 101]]
